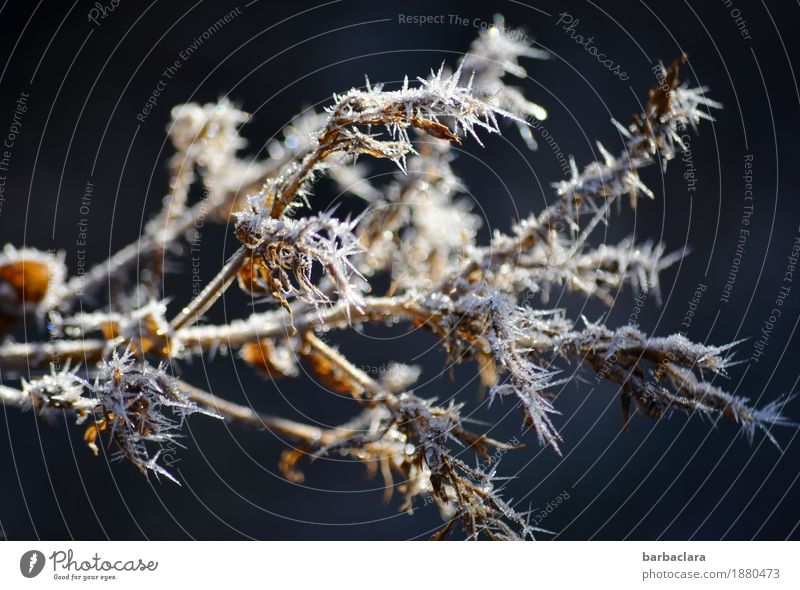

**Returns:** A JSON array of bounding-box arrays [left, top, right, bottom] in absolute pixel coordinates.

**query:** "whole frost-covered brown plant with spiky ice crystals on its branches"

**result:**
[[0, 15, 790, 539]]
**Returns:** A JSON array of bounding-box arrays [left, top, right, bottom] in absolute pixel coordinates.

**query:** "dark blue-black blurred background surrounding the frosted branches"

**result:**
[[0, 0, 800, 540]]
